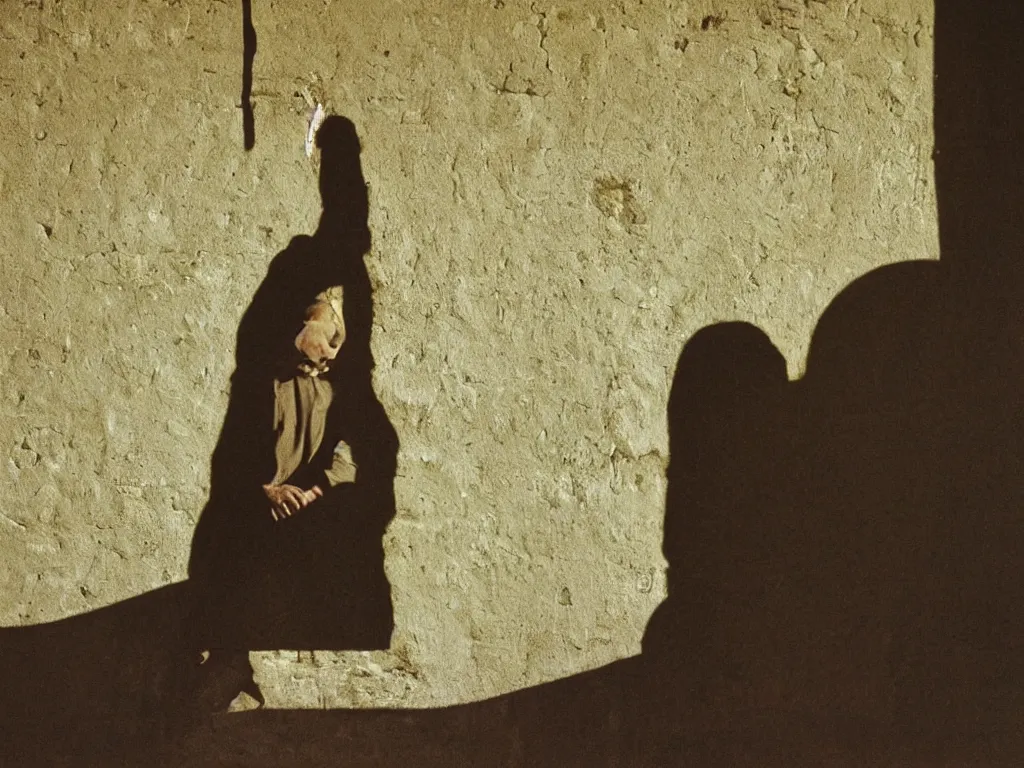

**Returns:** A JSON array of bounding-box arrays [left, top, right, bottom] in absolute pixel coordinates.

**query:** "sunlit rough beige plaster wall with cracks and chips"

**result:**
[[0, 0, 937, 706]]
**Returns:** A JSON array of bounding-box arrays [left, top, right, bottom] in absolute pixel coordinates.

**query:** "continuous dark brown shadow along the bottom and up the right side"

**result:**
[[0, 0, 1024, 767]]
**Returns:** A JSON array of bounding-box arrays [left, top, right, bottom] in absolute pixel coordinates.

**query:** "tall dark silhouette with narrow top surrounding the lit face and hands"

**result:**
[[188, 117, 398, 704]]
